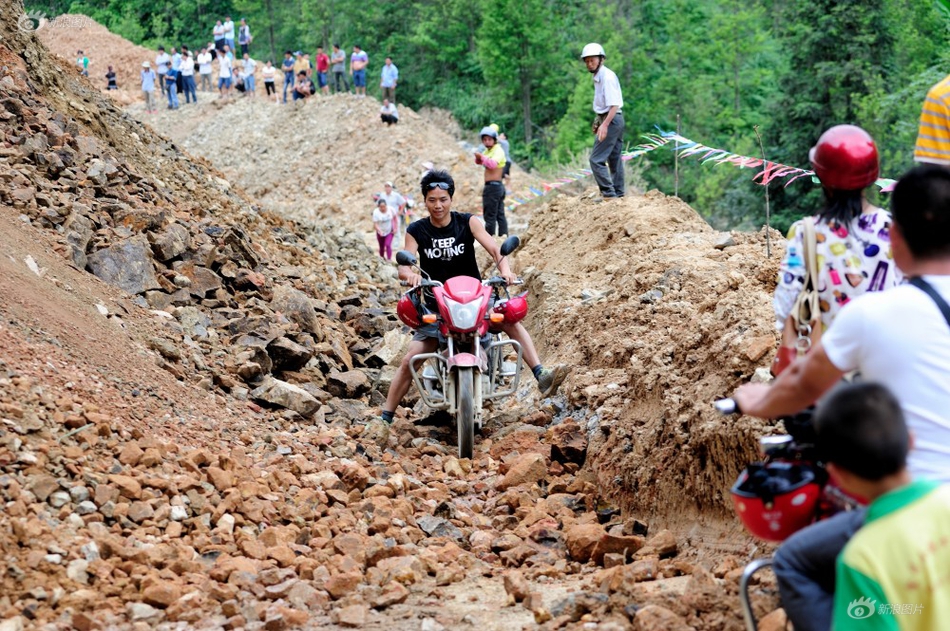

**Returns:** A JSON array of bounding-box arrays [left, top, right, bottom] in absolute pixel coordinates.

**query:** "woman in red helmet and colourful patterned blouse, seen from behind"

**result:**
[[774, 125, 903, 336]]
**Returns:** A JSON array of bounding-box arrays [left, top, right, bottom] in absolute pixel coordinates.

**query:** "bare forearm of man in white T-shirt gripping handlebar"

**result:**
[[733, 342, 844, 418]]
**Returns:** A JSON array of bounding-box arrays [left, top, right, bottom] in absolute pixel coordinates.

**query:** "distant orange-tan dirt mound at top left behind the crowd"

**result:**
[[36, 14, 155, 105]]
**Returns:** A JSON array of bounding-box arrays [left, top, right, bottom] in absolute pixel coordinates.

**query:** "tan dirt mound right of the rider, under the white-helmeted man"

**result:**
[[518, 191, 782, 520]]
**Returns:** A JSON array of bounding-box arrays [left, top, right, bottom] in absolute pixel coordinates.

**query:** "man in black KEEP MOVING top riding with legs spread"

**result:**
[[364, 170, 567, 446]]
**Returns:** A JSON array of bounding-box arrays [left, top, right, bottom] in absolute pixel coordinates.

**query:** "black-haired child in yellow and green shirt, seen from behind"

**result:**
[[812, 383, 950, 631]]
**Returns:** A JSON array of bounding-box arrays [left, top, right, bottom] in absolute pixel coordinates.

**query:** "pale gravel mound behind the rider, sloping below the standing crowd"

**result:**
[[130, 94, 536, 231]]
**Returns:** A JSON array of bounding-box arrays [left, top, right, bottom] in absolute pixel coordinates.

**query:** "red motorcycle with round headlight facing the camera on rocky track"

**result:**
[[396, 237, 528, 458]]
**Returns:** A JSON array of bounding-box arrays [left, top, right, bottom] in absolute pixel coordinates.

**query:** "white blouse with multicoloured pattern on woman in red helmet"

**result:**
[[773, 208, 904, 330]]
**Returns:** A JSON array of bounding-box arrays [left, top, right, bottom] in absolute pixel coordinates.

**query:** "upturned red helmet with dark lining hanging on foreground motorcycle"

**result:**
[[731, 461, 822, 541]]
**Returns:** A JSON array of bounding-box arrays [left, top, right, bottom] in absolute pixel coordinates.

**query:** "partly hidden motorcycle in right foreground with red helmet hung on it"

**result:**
[[715, 399, 864, 631]]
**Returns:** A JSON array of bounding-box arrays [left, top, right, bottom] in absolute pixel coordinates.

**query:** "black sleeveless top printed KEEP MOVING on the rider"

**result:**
[[406, 212, 481, 283]]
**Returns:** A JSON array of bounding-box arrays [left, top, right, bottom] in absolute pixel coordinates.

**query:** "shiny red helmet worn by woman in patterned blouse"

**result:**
[[808, 125, 880, 191]]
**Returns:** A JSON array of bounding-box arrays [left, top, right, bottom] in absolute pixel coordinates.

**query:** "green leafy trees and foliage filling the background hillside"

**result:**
[[28, 0, 950, 229]]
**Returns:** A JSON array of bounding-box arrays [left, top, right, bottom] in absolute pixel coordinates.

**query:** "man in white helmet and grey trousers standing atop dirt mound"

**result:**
[[581, 44, 624, 199]]
